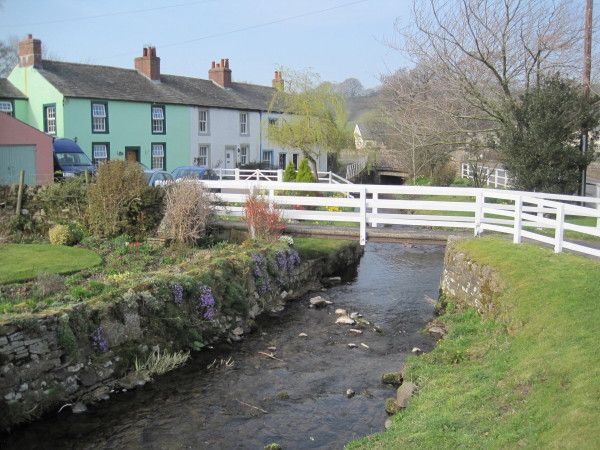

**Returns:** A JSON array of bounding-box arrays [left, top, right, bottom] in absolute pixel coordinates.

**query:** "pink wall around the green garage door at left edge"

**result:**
[[0, 112, 54, 184]]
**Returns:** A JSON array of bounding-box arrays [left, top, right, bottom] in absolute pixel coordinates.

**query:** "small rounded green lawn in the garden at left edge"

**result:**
[[0, 244, 102, 284]]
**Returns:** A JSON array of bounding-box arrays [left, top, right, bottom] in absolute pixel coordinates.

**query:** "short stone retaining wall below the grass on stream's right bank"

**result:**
[[440, 239, 500, 314]]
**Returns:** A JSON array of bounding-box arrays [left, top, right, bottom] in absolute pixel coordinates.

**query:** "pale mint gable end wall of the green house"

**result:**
[[8, 66, 67, 137]]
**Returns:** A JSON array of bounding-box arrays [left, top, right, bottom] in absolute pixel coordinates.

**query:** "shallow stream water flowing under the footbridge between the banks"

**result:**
[[0, 243, 444, 450]]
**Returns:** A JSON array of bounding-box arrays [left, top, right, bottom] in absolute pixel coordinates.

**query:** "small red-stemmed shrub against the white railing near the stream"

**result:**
[[244, 190, 285, 240]]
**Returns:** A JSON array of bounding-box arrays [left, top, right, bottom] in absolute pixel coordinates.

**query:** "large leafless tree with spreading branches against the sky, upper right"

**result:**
[[395, 0, 583, 131]]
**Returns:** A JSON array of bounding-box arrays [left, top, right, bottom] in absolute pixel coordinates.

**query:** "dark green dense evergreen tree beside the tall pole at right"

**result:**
[[499, 74, 599, 194]]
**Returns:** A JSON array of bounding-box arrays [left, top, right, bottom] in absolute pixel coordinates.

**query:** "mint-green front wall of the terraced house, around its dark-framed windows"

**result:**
[[65, 98, 190, 171]]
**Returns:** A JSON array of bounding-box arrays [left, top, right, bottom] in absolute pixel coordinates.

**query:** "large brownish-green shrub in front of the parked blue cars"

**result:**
[[88, 159, 147, 236]]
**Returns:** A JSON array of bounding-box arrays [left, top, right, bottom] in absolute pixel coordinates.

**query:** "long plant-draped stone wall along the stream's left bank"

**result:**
[[0, 244, 363, 429]]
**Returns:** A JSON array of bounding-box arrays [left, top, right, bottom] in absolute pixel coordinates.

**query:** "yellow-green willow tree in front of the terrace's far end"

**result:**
[[267, 71, 350, 177]]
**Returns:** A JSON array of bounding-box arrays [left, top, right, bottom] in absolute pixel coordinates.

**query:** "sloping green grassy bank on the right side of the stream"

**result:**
[[349, 238, 600, 449]]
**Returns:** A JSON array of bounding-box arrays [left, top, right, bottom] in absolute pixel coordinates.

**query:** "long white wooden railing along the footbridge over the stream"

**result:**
[[202, 181, 600, 257]]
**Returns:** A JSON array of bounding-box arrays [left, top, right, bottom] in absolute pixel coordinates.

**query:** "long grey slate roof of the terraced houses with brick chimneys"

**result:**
[[39, 61, 275, 111]]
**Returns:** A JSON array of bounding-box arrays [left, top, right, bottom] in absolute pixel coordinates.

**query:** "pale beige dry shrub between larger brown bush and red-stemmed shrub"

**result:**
[[163, 178, 214, 244]]
